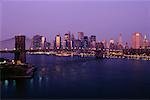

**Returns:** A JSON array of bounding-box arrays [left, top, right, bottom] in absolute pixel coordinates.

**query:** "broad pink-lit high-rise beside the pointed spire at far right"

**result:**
[[132, 32, 142, 49]]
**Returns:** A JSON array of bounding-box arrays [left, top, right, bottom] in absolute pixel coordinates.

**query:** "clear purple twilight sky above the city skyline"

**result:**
[[0, 0, 150, 45]]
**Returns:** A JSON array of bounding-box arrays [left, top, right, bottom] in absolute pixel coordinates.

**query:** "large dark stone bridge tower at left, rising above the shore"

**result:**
[[15, 35, 26, 63]]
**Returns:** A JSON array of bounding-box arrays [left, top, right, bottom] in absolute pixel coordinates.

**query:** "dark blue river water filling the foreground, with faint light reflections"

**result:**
[[0, 54, 150, 98]]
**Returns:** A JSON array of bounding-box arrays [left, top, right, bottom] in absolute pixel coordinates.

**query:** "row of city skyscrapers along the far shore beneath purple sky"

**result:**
[[0, 31, 150, 49]]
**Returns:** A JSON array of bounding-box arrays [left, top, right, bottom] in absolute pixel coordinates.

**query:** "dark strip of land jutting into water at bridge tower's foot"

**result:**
[[0, 59, 35, 80]]
